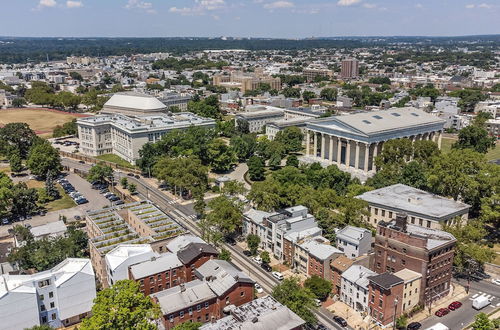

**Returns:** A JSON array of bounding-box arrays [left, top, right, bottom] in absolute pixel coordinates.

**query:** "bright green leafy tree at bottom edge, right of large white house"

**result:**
[[80, 280, 161, 330]]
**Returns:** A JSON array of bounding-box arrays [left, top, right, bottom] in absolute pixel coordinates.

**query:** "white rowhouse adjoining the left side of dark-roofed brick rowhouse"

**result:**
[[340, 265, 377, 312]]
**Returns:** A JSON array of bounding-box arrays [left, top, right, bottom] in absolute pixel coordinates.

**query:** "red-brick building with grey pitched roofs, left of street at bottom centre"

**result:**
[[151, 260, 255, 330]]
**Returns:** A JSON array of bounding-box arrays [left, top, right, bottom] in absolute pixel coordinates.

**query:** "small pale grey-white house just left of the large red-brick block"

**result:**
[[336, 226, 374, 259]]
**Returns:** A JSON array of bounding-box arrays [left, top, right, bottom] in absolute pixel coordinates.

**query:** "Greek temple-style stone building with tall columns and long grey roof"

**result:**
[[302, 107, 445, 180]]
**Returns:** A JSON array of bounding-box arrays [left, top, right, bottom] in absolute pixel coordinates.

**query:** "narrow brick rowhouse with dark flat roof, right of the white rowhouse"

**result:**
[[368, 273, 404, 328]]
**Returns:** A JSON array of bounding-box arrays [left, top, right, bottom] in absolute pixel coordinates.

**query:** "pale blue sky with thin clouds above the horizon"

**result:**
[[0, 0, 500, 38]]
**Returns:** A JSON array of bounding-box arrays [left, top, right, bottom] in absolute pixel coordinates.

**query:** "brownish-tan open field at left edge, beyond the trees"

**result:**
[[0, 109, 83, 136]]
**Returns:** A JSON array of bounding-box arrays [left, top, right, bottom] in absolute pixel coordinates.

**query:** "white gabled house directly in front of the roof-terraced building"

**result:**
[[105, 244, 155, 286]]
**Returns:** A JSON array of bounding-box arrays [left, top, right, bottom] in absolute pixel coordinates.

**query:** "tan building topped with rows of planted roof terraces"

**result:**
[[85, 201, 186, 287]]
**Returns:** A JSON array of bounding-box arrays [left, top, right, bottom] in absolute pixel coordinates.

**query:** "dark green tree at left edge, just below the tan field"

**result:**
[[0, 123, 37, 159]]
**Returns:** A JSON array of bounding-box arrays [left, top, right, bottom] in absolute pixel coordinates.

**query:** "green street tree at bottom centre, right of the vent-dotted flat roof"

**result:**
[[272, 277, 317, 325]]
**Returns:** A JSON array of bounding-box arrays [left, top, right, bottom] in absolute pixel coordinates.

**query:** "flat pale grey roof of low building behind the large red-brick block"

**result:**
[[356, 183, 470, 220]]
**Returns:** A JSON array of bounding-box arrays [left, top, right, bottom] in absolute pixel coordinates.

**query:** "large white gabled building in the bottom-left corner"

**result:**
[[0, 258, 96, 330]]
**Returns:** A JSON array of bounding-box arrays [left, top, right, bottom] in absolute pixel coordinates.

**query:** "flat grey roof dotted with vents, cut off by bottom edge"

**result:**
[[200, 296, 306, 330]]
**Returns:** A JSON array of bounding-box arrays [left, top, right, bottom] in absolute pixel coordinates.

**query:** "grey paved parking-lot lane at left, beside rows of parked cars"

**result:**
[[0, 173, 110, 237]]
